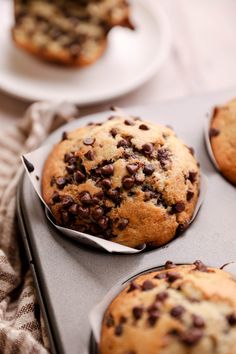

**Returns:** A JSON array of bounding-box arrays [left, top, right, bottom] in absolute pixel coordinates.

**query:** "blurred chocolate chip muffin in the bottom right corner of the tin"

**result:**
[[100, 261, 236, 354]]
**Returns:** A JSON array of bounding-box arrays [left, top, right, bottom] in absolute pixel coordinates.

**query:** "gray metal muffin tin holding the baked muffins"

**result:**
[[17, 91, 236, 354]]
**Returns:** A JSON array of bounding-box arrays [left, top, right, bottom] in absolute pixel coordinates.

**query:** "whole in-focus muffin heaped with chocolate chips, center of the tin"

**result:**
[[42, 114, 200, 247]]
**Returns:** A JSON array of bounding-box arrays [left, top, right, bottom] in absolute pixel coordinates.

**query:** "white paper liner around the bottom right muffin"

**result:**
[[89, 262, 236, 344]]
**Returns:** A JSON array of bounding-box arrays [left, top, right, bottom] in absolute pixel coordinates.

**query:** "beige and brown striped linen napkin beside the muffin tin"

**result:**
[[0, 102, 78, 354]]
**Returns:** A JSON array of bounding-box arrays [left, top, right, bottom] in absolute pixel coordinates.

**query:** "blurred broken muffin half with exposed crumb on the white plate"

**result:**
[[12, 0, 133, 66]]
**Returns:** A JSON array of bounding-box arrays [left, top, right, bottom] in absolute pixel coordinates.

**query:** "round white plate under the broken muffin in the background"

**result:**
[[0, 0, 171, 106]]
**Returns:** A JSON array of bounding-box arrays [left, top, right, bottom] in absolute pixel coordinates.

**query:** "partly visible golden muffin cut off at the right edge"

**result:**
[[210, 99, 236, 185]]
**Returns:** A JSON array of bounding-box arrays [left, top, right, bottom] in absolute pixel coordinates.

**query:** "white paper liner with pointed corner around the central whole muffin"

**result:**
[[22, 140, 207, 254]]
